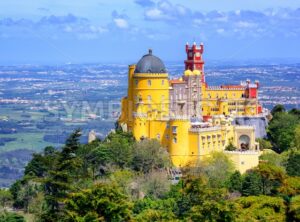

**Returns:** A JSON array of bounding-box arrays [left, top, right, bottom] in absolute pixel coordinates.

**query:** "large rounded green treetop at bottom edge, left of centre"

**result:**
[[65, 183, 132, 222]]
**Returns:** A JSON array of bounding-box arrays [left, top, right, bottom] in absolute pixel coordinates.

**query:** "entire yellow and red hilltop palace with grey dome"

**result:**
[[118, 43, 264, 172]]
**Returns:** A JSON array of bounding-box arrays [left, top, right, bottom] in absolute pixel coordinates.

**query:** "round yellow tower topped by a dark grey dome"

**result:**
[[132, 49, 169, 139]]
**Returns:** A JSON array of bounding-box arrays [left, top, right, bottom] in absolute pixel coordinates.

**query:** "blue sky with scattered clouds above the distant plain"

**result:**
[[0, 0, 300, 64]]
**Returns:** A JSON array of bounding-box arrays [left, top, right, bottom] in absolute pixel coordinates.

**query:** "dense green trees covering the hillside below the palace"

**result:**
[[0, 107, 300, 222]]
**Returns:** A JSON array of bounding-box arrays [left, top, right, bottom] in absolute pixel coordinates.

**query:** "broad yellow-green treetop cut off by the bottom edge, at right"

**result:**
[[236, 196, 286, 222]]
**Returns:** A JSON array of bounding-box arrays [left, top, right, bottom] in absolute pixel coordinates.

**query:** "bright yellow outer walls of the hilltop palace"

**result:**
[[119, 65, 258, 172]]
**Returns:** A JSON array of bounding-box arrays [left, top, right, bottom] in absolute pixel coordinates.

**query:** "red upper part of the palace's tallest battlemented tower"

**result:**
[[184, 42, 204, 82]]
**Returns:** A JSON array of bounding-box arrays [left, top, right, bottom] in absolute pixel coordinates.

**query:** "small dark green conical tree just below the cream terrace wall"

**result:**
[[242, 170, 262, 196]]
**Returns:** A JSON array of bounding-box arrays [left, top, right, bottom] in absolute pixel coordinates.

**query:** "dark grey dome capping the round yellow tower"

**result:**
[[134, 49, 167, 73]]
